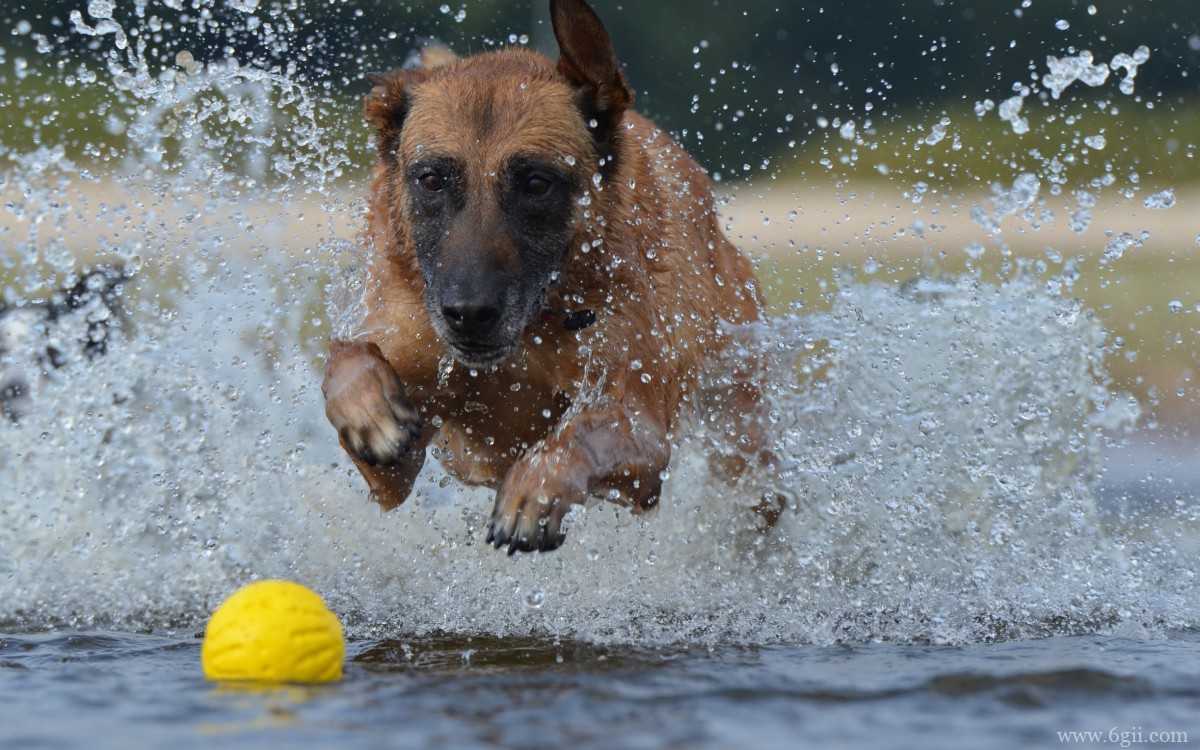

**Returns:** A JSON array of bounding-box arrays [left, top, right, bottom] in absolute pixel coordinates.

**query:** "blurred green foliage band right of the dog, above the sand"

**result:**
[[776, 95, 1200, 190]]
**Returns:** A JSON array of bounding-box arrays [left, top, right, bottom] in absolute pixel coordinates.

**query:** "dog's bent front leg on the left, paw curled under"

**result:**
[[322, 341, 427, 510]]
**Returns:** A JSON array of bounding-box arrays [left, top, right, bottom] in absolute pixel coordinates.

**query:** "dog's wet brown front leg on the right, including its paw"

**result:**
[[487, 401, 671, 554]]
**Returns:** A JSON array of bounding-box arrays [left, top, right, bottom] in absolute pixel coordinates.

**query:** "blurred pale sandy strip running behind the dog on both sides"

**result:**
[[0, 172, 1200, 262]]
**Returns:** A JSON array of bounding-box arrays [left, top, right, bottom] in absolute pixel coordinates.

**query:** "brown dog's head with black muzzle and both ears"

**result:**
[[365, 0, 632, 366]]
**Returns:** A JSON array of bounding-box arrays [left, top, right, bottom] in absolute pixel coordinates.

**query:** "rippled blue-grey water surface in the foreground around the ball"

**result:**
[[0, 632, 1200, 749]]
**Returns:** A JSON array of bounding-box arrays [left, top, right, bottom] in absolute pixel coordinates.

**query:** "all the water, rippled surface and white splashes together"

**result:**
[[0, 1, 1200, 748]]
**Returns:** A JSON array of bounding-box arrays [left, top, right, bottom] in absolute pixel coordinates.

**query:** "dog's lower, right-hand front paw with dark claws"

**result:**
[[487, 473, 584, 554]]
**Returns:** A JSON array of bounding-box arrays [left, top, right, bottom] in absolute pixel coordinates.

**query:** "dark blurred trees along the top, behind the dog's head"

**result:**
[[0, 0, 1200, 178]]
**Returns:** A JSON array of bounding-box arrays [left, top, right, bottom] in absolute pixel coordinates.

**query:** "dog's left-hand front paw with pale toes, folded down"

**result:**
[[322, 341, 421, 467]]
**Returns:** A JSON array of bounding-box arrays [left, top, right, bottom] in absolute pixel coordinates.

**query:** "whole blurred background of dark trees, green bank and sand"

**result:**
[[0, 0, 1200, 432]]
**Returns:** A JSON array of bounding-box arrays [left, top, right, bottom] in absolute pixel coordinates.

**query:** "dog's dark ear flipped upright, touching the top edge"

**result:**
[[550, 0, 634, 130]]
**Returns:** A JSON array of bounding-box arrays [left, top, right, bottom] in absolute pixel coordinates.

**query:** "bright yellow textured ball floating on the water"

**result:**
[[200, 581, 346, 683]]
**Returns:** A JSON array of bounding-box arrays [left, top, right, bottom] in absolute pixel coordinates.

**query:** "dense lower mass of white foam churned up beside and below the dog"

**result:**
[[0, 248, 1182, 642]]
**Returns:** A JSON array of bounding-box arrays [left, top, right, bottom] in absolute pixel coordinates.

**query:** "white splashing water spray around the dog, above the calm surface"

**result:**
[[0, 0, 1198, 642]]
